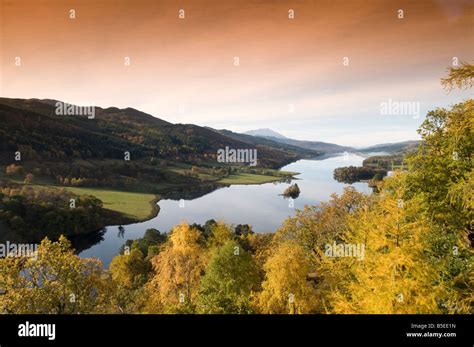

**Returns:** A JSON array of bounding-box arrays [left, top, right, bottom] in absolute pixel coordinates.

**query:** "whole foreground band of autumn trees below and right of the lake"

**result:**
[[0, 64, 474, 314]]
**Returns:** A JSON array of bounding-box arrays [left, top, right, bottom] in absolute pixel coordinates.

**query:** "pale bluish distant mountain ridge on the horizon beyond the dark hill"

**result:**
[[244, 129, 354, 154]]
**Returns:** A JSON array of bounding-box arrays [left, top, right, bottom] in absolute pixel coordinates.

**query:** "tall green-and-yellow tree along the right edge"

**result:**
[[405, 99, 474, 312]]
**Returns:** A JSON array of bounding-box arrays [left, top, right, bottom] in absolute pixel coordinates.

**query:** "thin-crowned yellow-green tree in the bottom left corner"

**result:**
[[0, 236, 110, 314]]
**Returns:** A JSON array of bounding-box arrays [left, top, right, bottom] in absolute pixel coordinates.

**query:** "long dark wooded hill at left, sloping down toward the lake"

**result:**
[[0, 98, 321, 192]]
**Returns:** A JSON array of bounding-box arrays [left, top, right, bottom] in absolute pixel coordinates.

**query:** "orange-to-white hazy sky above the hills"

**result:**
[[0, 0, 474, 146]]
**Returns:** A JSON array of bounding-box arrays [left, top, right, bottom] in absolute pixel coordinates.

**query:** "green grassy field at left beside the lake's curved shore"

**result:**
[[58, 187, 157, 220]]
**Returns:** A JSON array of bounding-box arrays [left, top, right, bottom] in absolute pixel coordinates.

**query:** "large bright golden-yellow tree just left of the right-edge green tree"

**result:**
[[324, 175, 444, 314]]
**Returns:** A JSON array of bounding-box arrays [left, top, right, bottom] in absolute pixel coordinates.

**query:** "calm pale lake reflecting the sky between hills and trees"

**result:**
[[80, 154, 371, 267]]
